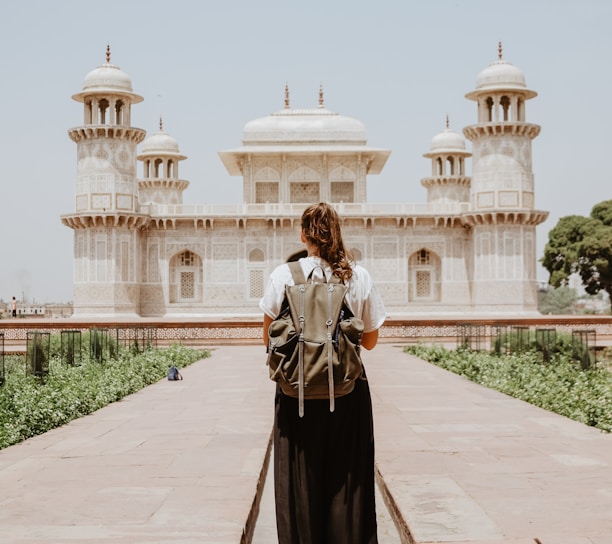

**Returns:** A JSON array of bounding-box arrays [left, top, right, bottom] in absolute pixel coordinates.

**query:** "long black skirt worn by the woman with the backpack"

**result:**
[[274, 380, 378, 544]]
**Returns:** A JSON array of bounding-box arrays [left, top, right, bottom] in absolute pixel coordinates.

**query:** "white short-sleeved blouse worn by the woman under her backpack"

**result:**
[[259, 257, 386, 332]]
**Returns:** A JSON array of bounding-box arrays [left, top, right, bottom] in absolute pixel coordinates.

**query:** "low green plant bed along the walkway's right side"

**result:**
[[405, 346, 612, 432]]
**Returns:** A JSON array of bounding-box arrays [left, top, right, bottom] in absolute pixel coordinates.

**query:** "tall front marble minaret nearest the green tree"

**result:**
[[463, 43, 548, 315]]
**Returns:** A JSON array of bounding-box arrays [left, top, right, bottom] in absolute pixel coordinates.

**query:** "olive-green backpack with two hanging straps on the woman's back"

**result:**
[[268, 262, 363, 417]]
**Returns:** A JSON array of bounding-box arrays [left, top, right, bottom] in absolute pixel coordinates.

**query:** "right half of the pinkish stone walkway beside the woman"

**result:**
[[364, 344, 612, 544]]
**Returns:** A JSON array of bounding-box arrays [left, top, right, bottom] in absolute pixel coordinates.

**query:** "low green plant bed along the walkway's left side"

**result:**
[[0, 345, 210, 448]]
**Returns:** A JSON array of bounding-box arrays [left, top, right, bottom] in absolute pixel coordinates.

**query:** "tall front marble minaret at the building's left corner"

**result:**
[[62, 46, 147, 316]]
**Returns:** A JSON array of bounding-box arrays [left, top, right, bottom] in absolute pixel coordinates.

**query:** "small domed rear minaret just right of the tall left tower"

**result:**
[[137, 118, 189, 205]]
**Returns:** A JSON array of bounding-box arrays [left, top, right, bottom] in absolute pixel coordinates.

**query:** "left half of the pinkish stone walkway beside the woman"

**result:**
[[0, 346, 273, 544]]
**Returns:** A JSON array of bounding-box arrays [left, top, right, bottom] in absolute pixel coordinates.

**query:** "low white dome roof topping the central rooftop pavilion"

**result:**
[[243, 107, 366, 145]]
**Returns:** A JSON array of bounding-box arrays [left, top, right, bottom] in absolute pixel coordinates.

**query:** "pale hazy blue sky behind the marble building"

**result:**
[[0, 0, 612, 303]]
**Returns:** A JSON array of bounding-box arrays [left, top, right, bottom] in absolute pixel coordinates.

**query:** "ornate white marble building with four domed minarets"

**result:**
[[62, 46, 548, 318]]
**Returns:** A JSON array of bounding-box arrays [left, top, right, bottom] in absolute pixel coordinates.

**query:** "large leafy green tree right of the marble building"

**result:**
[[541, 200, 612, 312]]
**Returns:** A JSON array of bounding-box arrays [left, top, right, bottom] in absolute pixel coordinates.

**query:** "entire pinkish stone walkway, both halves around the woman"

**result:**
[[0, 344, 612, 544]]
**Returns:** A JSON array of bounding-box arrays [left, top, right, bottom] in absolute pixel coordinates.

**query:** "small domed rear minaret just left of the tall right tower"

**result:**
[[421, 115, 471, 203]]
